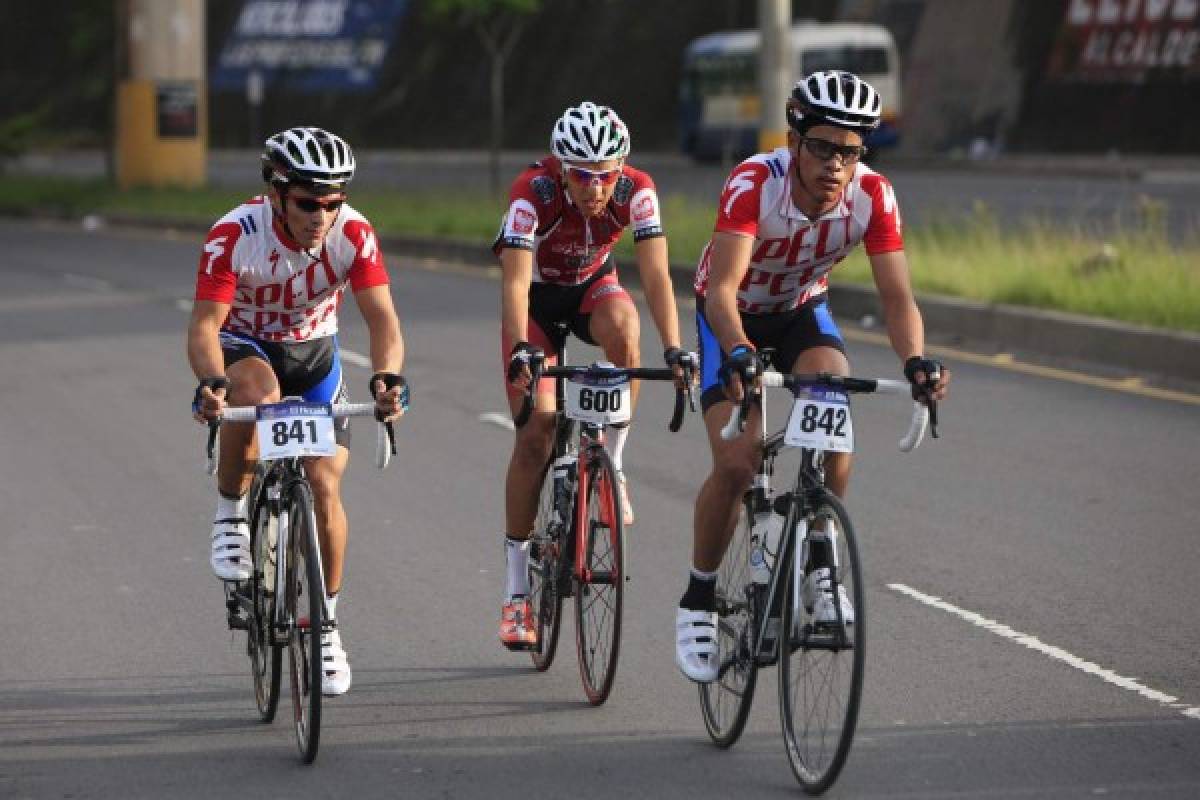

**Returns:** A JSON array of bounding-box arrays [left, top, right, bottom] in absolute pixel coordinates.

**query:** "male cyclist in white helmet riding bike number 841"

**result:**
[[187, 127, 407, 694]]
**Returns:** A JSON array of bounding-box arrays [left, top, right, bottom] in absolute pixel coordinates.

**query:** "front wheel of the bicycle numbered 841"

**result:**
[[286, 482, 325, 764]]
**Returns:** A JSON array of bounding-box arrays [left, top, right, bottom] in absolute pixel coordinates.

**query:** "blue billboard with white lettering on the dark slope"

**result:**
[[209, 0, 409, 91]]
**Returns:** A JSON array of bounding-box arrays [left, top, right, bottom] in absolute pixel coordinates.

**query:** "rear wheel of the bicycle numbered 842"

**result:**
[[700, 500, 766, 747]]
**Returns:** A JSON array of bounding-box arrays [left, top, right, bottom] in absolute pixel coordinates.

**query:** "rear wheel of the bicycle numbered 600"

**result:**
[[529, 457, 564, 672]]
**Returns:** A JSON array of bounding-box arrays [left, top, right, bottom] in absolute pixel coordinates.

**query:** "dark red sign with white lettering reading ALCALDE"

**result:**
[[1046, 0, 1200, 84]]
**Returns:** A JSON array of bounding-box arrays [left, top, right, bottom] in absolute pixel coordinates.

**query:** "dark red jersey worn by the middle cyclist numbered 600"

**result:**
[[492, 156, 662, 285]]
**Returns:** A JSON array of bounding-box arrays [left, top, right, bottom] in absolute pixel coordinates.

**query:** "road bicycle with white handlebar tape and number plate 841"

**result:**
[[208, 397, 396, 764]]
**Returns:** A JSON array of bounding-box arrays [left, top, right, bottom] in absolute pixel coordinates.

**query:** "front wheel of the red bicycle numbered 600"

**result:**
[[575, 447, 625, 705]]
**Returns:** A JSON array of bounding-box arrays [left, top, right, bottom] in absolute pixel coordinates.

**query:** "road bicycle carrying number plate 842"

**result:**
[[700, 362, 937, 794]]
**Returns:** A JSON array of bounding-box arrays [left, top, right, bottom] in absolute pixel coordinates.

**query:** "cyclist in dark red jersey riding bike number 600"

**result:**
[[493, 102, 683, 649]]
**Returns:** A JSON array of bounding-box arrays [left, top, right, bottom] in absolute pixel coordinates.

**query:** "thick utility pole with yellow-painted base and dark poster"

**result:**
[[114, 0, 208, 188]]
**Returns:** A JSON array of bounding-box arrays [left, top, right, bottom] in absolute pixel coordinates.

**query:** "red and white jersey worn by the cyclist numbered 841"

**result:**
[[196, 196, 388, 342]]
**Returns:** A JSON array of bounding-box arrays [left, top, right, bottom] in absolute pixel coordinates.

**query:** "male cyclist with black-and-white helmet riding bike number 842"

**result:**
[[676, 72, 949, 682]]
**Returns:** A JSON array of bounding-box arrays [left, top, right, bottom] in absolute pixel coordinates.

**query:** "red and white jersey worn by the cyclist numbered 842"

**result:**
[[695, 148, 904, 314]]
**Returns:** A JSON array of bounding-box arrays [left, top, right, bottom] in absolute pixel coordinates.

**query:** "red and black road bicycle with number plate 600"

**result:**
[[514, 350, 697, 705]]
